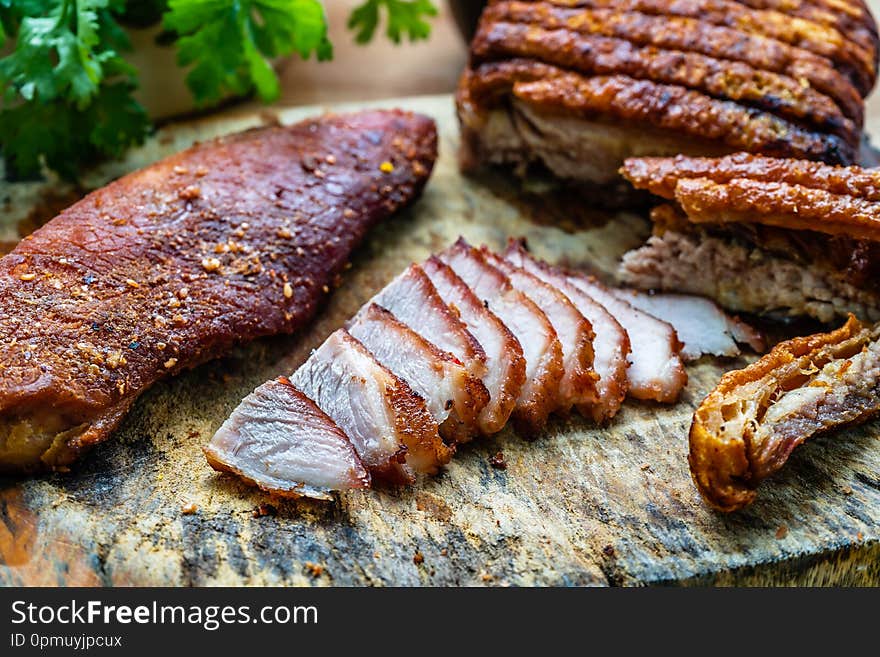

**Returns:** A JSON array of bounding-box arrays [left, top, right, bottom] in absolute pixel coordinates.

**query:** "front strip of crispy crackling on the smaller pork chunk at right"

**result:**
[[675, 178, 880, 241]]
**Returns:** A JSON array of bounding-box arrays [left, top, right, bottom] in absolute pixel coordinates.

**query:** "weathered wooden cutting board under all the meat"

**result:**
[[0, 96, 880, 585]]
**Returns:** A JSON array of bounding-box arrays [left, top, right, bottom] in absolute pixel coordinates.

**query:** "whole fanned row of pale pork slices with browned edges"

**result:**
[[206, 239, 756, 499]]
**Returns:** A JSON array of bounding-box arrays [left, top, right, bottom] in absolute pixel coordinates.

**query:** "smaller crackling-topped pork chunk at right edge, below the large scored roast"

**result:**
[[620, 153, 880, 322]]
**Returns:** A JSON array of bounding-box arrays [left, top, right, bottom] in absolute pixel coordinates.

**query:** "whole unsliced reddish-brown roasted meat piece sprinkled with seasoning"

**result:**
[[0, 112, 437, 472]]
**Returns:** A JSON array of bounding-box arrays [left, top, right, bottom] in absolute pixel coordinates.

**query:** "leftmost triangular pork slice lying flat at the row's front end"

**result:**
[[204, 377, 370, 500]]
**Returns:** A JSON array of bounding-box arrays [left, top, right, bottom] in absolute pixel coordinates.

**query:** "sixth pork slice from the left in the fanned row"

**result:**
[[439, 239, 564, 435]]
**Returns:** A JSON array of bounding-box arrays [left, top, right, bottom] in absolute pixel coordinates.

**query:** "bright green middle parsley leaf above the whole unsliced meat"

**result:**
[[163, 0, 333, 105]]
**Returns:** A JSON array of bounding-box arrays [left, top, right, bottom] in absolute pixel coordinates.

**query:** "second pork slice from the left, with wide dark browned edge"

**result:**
[[290, 329, 452, 483]]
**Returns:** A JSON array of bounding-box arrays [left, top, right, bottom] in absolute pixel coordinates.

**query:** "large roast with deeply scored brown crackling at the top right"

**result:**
[[457, 0, 880, 187]]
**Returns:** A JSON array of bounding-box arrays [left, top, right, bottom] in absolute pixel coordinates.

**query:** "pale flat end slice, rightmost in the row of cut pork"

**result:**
[[612, 290, 767, 360]]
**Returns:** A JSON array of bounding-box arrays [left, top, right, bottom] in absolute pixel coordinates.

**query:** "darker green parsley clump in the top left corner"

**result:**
[[0, 0, 149, 178]]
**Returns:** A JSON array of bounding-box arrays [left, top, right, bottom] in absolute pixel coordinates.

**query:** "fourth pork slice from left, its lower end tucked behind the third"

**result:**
[[372, 265, 486, 378]]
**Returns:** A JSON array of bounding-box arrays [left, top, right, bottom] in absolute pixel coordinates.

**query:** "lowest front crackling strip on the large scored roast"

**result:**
[[459, 59, 855, 163]]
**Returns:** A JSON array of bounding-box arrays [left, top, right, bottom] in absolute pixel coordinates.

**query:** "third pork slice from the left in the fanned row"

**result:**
[[348, 303, 489, 438]]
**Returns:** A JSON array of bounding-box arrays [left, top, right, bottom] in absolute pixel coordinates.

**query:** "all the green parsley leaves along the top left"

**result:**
[[0, 0, 437, 179]]
